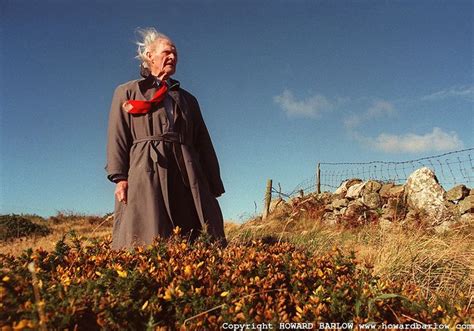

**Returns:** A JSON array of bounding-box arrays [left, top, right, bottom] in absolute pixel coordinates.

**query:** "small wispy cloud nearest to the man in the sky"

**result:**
[[273, 89, 334, 118]]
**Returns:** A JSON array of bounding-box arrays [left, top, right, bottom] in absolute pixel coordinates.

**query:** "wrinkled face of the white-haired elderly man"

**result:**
[[146, 39, 178, 80]]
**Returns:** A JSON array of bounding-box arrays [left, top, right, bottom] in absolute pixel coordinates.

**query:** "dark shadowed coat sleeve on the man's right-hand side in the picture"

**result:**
[[192, 97, 225, 197]]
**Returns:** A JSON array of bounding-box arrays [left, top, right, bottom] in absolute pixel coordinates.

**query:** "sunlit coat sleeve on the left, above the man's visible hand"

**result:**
[[105, 86, 132, 181]]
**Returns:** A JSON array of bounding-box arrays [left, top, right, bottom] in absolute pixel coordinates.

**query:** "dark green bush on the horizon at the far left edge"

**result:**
[[0, 214, 51, 241]]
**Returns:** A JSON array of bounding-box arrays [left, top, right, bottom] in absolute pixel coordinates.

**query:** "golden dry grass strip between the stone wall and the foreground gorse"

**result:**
[[228, 218, 474, 307]]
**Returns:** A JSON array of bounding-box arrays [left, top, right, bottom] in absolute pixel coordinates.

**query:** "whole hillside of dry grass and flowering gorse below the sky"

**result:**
[[0, 185, 474, 330]]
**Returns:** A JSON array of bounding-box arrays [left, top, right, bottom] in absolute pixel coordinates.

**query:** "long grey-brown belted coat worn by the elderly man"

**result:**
[[105, 76, 225, 249]]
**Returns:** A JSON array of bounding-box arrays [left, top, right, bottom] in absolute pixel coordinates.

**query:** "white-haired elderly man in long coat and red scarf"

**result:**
[[106, 28, 226, 249]]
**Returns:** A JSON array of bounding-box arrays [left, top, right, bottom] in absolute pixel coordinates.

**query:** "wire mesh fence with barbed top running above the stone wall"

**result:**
[[271, 148, 474, 198]]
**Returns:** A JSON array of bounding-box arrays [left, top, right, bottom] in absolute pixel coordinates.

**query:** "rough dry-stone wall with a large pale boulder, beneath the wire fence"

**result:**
[[270, 167, 474, 231]]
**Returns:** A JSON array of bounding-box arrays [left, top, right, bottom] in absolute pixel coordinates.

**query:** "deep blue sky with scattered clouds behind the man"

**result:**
[[0, 0, 474, 221]]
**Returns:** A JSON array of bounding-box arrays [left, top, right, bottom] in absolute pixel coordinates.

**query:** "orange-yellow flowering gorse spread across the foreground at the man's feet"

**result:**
[[0, 230, 472, 330]]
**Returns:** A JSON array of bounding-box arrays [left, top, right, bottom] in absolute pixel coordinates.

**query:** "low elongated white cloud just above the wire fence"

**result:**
[[358, 127, 463, 153]]
